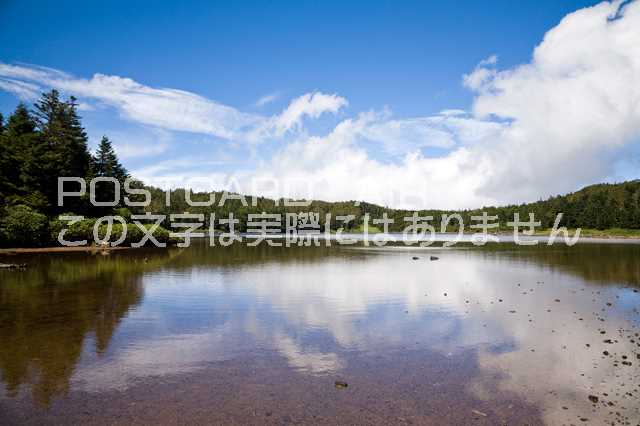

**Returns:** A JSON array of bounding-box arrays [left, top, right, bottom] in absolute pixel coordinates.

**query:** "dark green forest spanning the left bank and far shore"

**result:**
[[0, 90, 640, 247]]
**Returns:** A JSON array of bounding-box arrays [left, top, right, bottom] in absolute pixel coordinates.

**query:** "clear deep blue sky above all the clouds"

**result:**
[[0, 0, 596, 115]]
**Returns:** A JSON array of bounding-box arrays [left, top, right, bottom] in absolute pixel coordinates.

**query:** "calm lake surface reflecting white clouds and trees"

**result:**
[[0, 244, 640, 425]]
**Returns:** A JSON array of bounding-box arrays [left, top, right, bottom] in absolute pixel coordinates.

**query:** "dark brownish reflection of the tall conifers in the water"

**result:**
[[0, 253, 178, 405]]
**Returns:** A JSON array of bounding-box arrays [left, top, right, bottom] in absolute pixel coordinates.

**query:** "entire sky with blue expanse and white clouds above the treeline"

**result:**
[[0, 0, 640, 208]]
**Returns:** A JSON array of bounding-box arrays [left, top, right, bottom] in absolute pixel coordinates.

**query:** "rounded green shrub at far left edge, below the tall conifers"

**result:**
[[0, 204, 49, 247]]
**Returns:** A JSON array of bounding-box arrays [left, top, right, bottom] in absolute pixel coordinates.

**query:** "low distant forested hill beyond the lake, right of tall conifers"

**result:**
[[147, 180, 640, 231]]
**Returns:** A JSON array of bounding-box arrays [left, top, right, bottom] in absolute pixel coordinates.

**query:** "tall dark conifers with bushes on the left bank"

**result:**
[[0, 90, 129, 246]]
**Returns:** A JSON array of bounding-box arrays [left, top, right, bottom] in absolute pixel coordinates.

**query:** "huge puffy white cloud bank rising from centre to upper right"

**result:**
[[244, 1, 640, 207]]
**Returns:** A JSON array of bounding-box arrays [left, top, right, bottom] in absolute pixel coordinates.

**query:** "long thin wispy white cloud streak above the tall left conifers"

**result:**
[[0, 63, 348, 142]]
